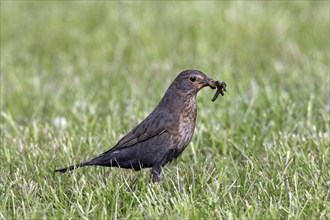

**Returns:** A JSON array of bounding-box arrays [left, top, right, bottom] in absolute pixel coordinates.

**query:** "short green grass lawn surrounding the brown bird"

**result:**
[[0, 1, 330, 219]]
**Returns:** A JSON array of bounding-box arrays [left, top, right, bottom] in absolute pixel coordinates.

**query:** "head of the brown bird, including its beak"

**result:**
[[173, 70, 216, 94]]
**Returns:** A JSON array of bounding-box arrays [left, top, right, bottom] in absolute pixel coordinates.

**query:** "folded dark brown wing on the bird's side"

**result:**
[[113, 111, 166, 149]]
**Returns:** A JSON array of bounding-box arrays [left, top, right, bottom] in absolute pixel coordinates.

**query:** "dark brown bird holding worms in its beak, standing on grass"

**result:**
[[55, 70, 226, 183]]
